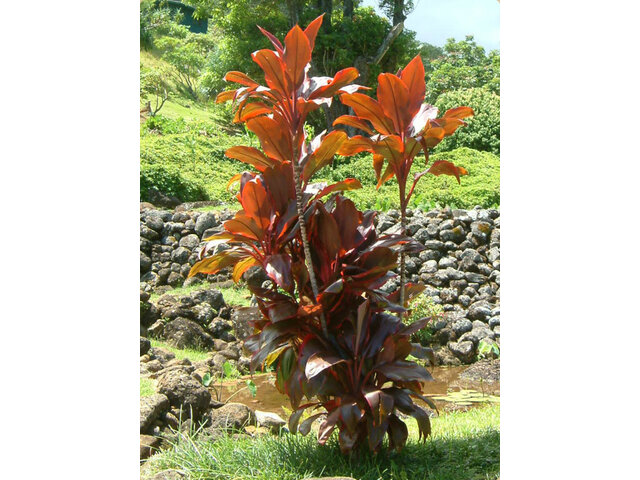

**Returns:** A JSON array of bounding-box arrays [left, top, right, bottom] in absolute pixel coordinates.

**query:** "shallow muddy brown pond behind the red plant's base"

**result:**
[[210, 366, 500, 418]]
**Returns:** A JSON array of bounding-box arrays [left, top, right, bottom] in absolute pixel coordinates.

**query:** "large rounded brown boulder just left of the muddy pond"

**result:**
[[156, 369, 211, 419]]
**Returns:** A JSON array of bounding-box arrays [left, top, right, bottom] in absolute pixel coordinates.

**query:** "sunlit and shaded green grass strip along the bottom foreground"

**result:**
[[145, 405, 500, 480]]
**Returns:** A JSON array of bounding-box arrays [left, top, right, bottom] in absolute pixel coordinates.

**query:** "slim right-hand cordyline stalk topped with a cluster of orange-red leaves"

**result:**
[[333, 55, 473, 305]]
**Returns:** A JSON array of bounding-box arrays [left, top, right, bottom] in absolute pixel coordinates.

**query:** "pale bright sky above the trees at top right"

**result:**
[[362, 0, 500, 51]]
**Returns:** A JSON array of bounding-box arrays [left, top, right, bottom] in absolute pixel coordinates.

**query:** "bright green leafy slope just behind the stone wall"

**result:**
[[140, 52, 500, 210]]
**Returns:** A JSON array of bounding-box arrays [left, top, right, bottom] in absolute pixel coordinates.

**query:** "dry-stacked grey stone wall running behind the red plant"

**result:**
[[140, 202, 500, 364]]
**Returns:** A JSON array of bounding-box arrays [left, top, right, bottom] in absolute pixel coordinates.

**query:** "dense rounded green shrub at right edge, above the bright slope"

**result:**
[[435, 88, 500, 155]]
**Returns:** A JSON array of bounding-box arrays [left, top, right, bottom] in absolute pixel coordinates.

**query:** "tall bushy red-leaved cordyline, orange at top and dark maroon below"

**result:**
[[190, 17, 435, 452]]
